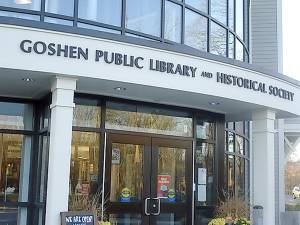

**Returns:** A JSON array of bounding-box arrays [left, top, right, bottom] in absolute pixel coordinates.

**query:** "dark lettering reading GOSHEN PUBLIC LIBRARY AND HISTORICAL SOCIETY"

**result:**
[[19, 40, 294, 101]]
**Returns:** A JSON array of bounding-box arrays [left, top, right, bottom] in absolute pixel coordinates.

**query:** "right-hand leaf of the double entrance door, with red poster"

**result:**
[[150, 138, 193, 225]]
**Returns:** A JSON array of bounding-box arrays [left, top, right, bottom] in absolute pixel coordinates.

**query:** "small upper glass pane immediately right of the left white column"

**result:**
[[73, 105, 101, 128]]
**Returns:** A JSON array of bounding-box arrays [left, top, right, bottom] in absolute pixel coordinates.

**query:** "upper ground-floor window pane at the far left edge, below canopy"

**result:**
[[0, 102, 33, 130]]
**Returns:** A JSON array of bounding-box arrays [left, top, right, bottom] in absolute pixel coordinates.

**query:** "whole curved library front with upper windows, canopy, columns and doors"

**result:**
[[0, 0, 300, 225]]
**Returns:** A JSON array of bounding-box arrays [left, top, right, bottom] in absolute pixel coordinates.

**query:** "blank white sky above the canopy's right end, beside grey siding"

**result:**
[[282, 0, 300, 80]]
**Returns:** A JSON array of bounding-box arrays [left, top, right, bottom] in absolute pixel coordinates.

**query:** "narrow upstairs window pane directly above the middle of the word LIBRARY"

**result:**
[[165, 1, 182, 43]]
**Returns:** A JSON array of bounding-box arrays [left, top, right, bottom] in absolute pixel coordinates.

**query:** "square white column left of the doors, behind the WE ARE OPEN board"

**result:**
[[45, 77, 76, 225]]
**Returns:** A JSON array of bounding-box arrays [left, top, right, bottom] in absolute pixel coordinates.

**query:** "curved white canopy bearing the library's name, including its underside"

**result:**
[[0, 25, 300, 120]]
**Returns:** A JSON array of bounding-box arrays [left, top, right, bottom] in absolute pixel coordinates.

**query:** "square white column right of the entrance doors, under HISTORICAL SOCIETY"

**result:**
[[252, 110, 275, 225]]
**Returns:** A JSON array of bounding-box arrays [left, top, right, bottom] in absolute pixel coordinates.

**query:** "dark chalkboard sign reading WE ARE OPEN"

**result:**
[[60, 211, 98, 225]]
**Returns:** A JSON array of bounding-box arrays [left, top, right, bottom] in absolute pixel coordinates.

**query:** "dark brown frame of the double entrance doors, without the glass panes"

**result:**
[[102, 132, 194, 224]]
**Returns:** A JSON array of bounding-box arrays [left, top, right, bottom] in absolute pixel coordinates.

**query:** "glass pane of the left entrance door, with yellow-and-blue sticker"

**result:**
[[110, 143, 144, 202]]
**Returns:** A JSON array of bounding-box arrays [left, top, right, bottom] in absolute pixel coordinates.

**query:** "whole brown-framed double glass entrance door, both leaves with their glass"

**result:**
[[105, 134, 193, 225]]
